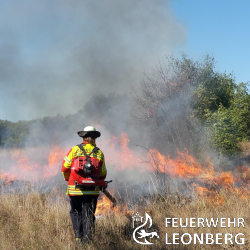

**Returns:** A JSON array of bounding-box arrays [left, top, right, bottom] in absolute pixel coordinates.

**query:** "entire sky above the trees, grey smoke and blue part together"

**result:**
[[0, 0, 250, 121]]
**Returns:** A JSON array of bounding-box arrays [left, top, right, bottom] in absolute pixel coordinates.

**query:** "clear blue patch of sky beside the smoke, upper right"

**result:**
[[172, 0, 250, 83]]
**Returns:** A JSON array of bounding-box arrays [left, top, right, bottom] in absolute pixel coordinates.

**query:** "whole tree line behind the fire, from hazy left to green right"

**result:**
[[0, 54, 250, 155]]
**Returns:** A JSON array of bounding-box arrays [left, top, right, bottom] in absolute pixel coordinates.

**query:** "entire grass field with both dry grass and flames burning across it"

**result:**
[[0, 138, 250, 250]]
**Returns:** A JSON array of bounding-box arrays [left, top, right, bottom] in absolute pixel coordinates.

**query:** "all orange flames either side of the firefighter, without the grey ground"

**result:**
[[0, 133, 250, 208]]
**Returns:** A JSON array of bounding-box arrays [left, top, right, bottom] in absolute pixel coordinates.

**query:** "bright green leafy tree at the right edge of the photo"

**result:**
[[207, 83, 250, 155]]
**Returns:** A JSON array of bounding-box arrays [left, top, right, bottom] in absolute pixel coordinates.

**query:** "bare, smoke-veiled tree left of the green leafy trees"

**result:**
[[133, 54, 207, 154]]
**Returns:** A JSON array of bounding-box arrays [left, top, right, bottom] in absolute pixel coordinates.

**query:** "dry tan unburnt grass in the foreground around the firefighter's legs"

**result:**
[[0, 188, 250, 250]]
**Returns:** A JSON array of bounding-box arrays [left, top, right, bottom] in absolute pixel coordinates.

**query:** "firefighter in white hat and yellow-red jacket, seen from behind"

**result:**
[[62, 126, 107, 244]]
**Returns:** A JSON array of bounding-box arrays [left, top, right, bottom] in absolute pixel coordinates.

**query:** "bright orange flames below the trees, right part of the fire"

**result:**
[[146, 149, 250, 205]]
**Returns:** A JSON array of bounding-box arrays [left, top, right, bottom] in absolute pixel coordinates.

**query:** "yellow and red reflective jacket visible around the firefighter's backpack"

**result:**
[[62, 141, 107, 196]]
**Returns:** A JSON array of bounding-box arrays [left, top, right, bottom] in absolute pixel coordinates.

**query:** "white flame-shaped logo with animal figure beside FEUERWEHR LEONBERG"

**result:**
[[132, 212, 159, 245]]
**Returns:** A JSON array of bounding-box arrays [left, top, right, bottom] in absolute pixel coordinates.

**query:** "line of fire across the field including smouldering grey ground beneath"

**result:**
[[0, 133, 250, 218]]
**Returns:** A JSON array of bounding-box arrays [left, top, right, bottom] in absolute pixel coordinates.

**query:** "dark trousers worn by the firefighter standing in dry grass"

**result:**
[[70, 195, 98, 242]]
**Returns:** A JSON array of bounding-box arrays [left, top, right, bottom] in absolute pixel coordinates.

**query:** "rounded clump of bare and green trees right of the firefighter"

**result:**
[[133, 54, 250, 155]]
